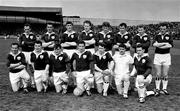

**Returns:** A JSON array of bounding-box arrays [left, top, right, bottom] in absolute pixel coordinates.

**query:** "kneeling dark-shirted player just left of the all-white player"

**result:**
[[93, 43, 114, 96]]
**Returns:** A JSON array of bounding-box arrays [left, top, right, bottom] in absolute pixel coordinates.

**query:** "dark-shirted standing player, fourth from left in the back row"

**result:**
[[79, 20, 95, 54]]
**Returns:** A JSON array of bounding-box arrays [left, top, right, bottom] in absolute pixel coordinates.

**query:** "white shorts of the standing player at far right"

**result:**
[[154, 54, 171, 65]]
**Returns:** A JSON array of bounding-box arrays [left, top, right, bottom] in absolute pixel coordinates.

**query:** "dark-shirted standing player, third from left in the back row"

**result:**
[[61, 21, 78, 58]]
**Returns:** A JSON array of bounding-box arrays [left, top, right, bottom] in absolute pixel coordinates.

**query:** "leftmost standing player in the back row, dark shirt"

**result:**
[[19, 24, 36, 88]]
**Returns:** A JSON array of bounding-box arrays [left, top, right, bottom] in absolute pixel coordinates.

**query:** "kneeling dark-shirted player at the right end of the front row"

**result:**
[[131, 44, 154, 103]]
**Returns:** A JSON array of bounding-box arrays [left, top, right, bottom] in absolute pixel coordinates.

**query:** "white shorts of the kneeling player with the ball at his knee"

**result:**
[[76, 70, 94, 84]]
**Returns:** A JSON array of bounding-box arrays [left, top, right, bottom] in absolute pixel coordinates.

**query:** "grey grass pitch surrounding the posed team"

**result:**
[[0, 39, 180, 111]]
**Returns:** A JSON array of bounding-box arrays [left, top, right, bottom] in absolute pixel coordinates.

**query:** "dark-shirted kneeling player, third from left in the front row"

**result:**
[[50, 44, 70, 94]]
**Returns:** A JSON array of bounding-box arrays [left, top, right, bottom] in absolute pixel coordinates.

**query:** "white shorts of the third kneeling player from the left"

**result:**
[[53, 72, 69, 86]]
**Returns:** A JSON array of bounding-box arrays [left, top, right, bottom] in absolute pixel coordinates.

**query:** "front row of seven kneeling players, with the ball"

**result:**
[[7, 41, 152, 102]]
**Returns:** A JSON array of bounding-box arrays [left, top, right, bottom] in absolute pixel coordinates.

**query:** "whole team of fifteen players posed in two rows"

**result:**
[[7, 20, 173, 103]]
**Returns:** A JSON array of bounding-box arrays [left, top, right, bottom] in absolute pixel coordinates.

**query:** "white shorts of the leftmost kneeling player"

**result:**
[[9, 69, 30, 84]]
